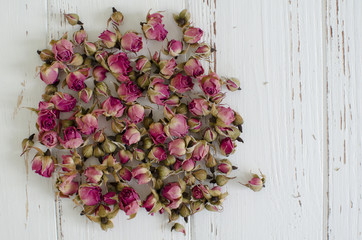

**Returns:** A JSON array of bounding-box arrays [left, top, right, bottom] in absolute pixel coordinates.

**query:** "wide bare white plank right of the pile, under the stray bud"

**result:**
[[192, 0, 325, 240]]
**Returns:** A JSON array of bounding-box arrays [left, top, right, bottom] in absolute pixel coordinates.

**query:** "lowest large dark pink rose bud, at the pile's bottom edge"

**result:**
[[118, 187, 141, 216]]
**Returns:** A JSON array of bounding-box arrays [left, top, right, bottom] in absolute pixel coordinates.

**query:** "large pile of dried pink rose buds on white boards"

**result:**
[[23, 8, 247, 232]]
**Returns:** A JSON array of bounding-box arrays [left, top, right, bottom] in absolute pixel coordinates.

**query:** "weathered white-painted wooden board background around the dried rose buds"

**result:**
[[0, 0, 362, 240]]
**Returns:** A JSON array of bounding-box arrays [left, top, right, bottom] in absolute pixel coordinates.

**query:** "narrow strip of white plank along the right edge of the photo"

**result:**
[[326, 0, 362, 239]]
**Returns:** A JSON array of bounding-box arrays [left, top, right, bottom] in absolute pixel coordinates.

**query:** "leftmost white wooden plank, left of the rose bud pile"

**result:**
[[0, 0, 56, 240]]
